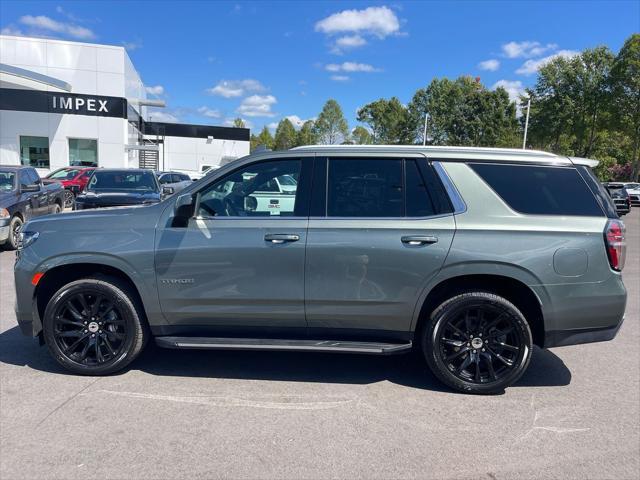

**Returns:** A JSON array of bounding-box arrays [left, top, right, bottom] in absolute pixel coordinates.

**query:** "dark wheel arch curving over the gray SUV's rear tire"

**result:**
[[413, 273, 545, 347]]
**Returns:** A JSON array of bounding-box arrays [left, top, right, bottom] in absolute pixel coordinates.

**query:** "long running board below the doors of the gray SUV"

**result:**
[[156, 337, 412, 355]]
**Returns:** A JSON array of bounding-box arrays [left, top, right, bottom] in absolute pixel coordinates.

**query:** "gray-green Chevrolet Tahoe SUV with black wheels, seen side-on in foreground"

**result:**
[[15, 146, 626, 393]]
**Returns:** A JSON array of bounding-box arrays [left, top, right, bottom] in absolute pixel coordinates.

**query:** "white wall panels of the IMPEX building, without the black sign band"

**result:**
[[0, 35, 249, 175]]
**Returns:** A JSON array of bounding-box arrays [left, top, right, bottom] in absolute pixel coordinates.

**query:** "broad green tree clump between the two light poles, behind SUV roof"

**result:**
[[407, 76, 519, 147]]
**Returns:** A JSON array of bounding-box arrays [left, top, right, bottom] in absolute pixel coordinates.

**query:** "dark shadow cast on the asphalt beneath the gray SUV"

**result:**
[[0, 327, 571, 392]]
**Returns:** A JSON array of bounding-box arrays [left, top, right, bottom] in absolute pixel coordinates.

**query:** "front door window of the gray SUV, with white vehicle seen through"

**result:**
[[197, 160, 302, 217]]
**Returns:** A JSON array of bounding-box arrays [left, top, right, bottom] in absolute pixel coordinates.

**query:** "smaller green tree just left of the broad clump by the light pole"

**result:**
[[358, 97, 413, 145]]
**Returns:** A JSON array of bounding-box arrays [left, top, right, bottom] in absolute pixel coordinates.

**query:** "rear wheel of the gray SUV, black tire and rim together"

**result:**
[[421, 292, 533, 394]]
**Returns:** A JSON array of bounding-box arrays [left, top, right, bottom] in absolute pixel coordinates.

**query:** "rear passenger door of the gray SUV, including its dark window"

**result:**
[[305, 156, 455, 334]]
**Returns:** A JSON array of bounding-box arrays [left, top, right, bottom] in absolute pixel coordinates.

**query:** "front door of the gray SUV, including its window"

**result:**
[[156, 158, 313, 329]]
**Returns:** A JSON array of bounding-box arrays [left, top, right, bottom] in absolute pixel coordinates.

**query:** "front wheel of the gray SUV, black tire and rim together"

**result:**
[[43, 276, 149, 375]]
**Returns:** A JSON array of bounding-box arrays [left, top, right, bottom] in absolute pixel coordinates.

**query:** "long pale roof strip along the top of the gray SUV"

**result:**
[[292, 145, 572, 165]]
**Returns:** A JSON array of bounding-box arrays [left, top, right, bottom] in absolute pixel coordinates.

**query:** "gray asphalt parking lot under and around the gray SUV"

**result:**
[[0, 208, 640, 479]]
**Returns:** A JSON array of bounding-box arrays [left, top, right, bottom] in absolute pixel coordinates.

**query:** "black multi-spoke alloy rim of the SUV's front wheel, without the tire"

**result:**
[[53, 290, 127, 366]]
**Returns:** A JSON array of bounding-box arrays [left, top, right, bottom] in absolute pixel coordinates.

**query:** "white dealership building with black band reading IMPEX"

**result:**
[[0, 35, 249, 175]]
